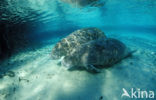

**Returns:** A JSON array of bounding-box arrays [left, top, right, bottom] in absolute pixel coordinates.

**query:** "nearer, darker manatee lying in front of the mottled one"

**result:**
[[61, 38, 131, 72]]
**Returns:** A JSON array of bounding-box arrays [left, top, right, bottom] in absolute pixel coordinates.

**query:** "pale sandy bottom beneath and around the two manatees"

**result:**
[[0, 31, 156, 100]]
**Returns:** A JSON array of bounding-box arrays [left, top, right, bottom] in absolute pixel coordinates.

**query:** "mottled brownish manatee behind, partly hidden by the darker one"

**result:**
[[51, 27, 106, 60]]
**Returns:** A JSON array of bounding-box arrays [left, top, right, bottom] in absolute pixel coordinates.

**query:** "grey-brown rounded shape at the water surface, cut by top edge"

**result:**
[[61, 0, 103, 7]]
